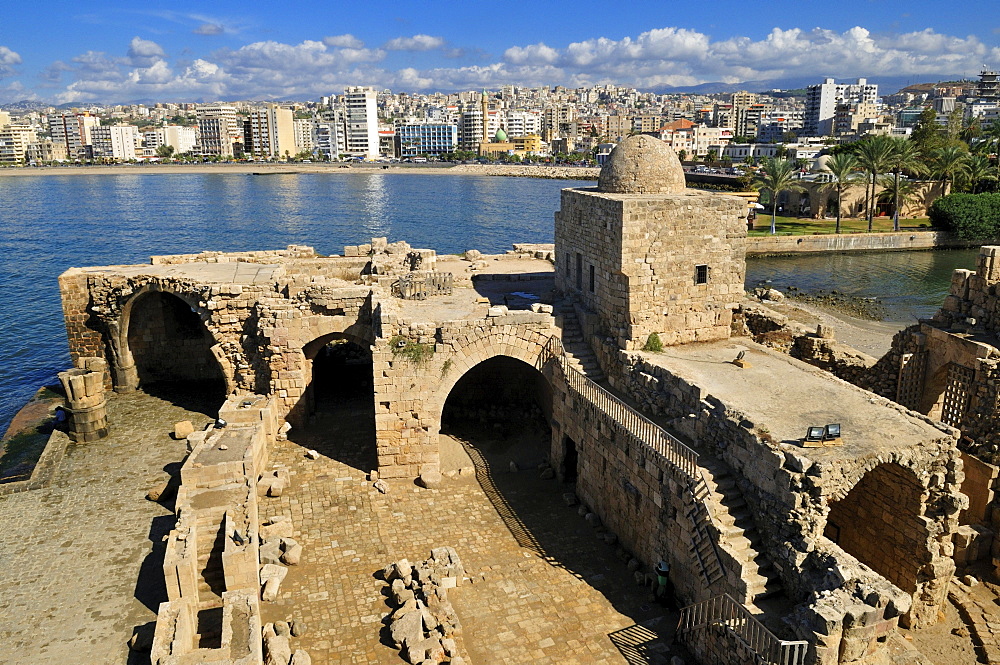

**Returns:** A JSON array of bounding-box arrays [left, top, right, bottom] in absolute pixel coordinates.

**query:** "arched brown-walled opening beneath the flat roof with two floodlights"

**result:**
[[824, 463, 932, 593]]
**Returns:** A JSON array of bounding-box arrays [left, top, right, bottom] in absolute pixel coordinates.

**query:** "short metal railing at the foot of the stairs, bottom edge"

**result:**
[[677, 594, 809, 665]]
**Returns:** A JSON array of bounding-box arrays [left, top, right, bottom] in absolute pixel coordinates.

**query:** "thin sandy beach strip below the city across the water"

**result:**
[[0, 163, 599, 180]]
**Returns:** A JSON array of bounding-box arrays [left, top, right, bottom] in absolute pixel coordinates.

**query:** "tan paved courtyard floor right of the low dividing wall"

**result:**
[[261, 396, 676, 665]]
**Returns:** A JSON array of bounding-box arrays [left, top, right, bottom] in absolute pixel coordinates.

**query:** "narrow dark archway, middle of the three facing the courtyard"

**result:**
[[287, 333, 378, 472]]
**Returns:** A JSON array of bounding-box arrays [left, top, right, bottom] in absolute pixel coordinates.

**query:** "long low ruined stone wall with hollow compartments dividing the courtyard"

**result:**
[[150, 395, 278, 665]]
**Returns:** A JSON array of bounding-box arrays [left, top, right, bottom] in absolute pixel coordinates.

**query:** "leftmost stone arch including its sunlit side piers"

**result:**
[[120, 284, 236, 395]]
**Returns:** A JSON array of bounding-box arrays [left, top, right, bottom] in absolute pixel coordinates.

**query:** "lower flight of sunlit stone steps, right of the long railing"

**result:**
[[699, 456, 783, 613]]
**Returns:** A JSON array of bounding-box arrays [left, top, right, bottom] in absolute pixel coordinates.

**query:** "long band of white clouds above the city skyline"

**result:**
[[37, 24, 1000, 102]]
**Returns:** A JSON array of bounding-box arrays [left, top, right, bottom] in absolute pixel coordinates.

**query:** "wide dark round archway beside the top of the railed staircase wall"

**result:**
[[440, 356, 552, 471]]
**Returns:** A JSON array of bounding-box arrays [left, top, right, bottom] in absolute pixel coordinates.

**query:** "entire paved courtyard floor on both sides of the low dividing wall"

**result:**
[[0, 386, 676, 665]]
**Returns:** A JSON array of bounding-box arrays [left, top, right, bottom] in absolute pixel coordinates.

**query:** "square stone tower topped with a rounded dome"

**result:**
[[555, 135, 746, 349]]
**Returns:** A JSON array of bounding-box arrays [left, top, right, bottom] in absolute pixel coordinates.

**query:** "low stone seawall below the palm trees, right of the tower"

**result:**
[[747, 231, 989, 256]]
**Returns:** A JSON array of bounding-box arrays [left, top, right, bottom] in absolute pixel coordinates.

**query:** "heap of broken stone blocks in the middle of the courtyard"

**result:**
[[382, 547, 469, 665]]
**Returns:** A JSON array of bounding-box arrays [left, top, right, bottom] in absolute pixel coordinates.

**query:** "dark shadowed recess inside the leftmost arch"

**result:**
[[127, 291, 227, 416]]
